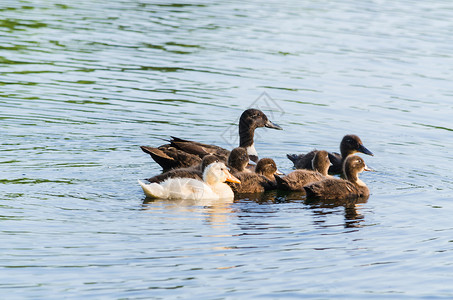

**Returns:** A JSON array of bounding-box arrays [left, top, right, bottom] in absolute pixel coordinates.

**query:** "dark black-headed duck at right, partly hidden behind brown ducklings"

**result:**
[[286, 134, 374, 174]]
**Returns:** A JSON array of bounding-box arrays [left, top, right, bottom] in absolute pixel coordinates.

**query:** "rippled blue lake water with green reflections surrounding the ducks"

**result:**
[[0, 0, 453, 299]]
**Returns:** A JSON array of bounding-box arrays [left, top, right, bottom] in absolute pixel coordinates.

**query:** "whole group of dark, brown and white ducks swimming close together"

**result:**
[[139, 108, 373, 200]]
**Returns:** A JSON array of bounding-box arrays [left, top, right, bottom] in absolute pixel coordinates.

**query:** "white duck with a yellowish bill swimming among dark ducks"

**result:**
[[138, 162, 240, 200]]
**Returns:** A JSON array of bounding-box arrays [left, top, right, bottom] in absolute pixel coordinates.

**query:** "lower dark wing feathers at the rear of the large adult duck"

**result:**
[[140, 145, 201, 172]]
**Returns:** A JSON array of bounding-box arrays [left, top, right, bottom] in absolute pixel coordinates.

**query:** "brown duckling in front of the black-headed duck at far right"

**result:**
[[304, 155, 371, 200]]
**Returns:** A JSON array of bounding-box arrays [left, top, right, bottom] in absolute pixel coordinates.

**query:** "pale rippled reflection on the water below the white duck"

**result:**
[[142, 197, 234, 227]]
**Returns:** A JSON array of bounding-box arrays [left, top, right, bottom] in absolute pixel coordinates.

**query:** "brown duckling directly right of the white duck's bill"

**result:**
[[228, 158, 281, 194]]
